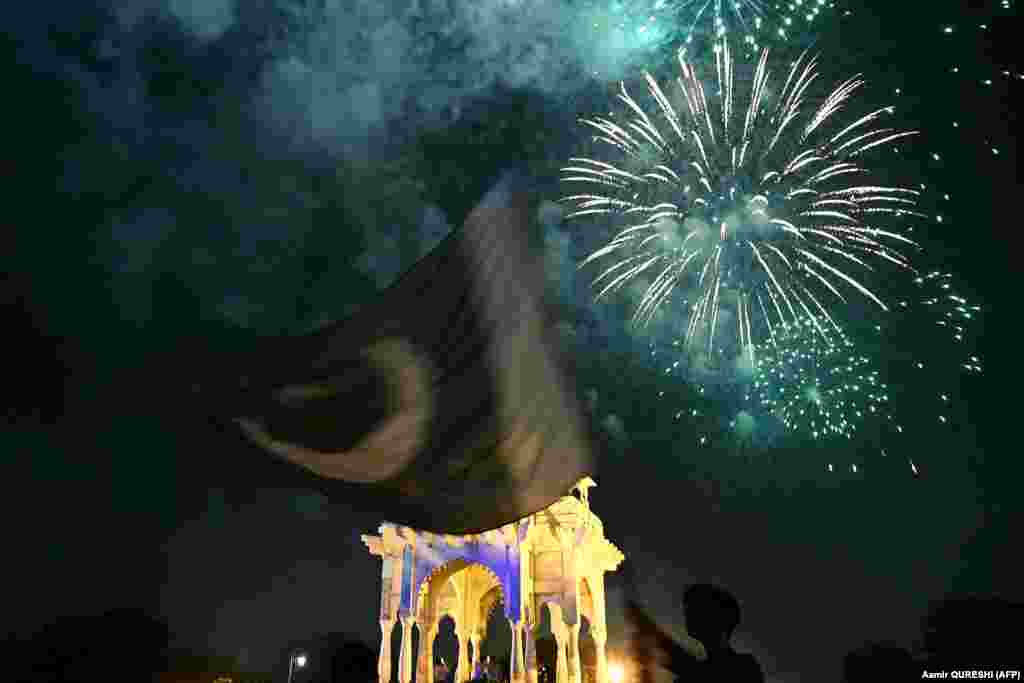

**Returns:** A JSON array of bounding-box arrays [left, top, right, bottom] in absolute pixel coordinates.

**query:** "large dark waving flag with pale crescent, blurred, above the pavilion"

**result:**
[[201, 176, 592, 533]]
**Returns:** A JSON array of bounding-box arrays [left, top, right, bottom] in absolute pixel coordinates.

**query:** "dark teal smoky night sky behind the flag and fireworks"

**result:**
[[0, 0, 1024, 682]]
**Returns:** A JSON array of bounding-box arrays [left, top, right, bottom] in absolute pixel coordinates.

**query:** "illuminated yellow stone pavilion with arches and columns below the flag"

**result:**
[[361, 478, 623, 683]]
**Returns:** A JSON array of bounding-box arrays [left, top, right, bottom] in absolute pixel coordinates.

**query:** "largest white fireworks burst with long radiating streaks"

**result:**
[[562, 45, 925, 362]]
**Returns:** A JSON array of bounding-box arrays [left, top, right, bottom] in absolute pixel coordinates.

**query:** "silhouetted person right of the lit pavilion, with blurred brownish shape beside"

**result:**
[[627, 584, 765, 683]]
